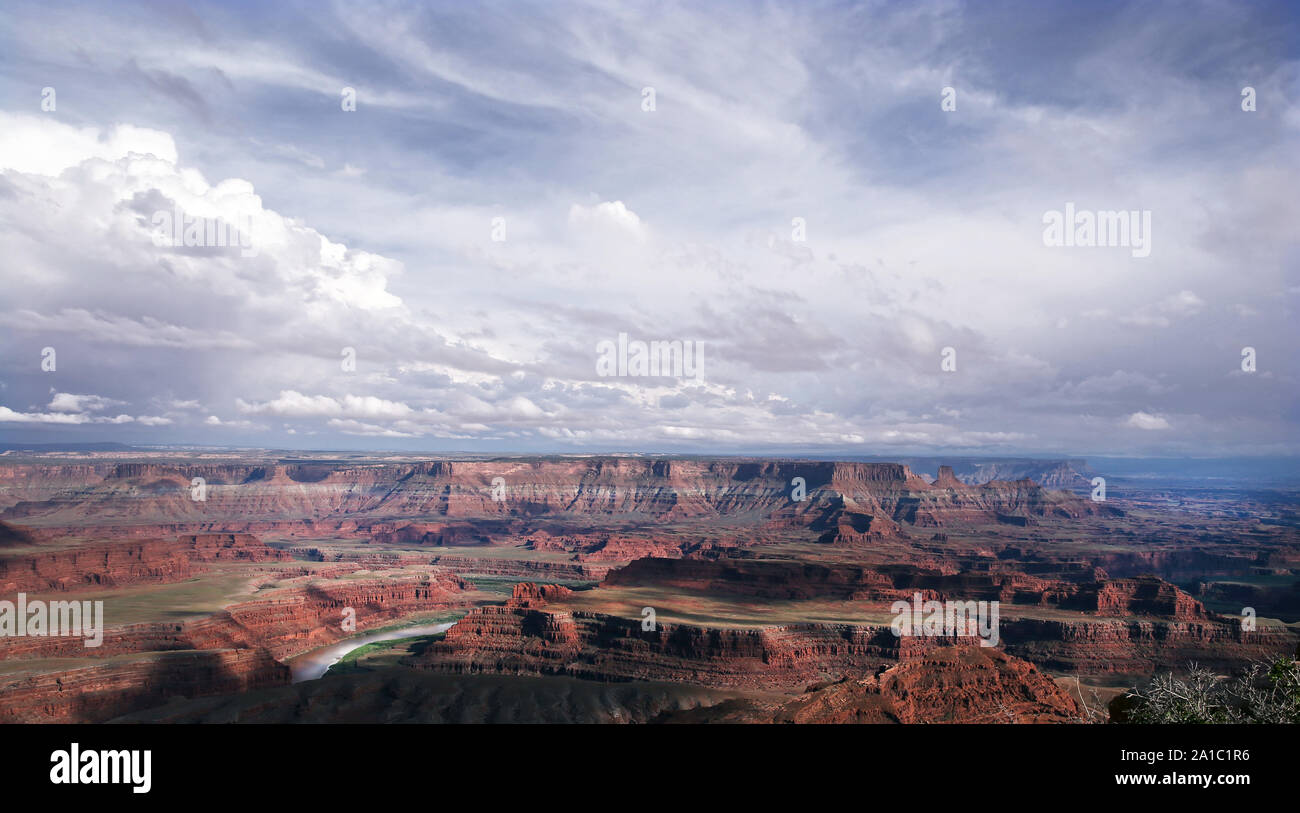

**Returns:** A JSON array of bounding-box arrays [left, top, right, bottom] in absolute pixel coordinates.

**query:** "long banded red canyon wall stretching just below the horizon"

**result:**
[[0, 458, 1100, 544]]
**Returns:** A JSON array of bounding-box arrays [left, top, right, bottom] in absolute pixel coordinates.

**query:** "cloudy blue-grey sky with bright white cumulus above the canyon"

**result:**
[[0, 1, 1300, 455]]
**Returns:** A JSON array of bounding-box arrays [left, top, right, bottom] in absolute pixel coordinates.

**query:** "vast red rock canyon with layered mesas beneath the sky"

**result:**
[[0, 451, 1300, 723]]
